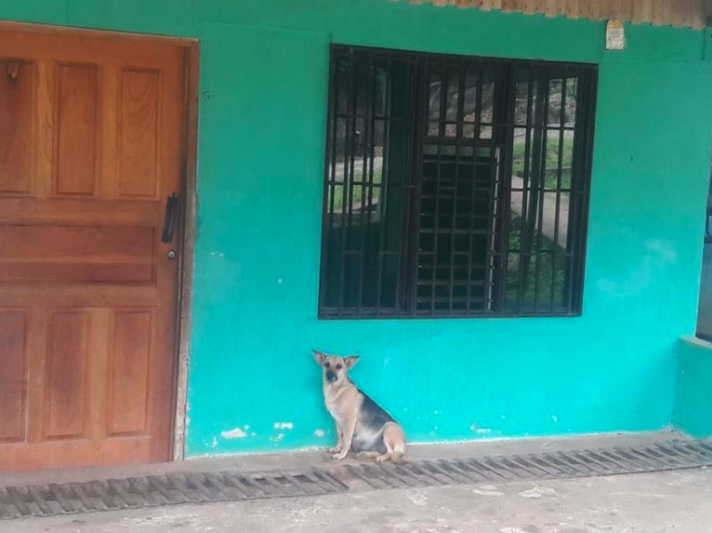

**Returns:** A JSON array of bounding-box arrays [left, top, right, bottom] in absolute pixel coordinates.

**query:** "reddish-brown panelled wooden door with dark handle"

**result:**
[[0, 25, 186, 471]]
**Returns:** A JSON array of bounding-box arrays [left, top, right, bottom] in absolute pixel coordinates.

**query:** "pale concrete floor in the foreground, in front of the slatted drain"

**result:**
[[0, 469, 712, 533]]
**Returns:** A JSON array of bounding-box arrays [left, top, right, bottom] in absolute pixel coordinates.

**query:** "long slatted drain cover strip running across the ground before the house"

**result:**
[[0, 441, 712, 519]]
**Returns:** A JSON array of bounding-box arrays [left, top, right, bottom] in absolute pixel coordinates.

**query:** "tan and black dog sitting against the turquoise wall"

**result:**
[[313, 350, 406, 463]]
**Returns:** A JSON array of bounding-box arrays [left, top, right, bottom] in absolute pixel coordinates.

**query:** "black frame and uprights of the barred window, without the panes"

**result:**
[[318, 44, 598, 321]]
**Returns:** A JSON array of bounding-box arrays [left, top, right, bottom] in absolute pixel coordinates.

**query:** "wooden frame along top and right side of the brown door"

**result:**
[[0, 20, 200, 461]]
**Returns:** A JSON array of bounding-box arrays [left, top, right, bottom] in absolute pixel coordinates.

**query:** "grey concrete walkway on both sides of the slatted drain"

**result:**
[[0, 433, 712, 533]]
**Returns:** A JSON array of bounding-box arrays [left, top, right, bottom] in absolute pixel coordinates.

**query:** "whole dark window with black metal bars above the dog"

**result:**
[[319, 46, 596, 318]]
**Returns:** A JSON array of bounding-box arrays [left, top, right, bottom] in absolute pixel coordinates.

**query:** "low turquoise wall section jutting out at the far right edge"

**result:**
[[673, 337, 712, 438]]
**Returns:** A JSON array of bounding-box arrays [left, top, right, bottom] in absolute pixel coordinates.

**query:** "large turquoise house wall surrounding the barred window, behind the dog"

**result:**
[[0, 0, 712, 456]]
